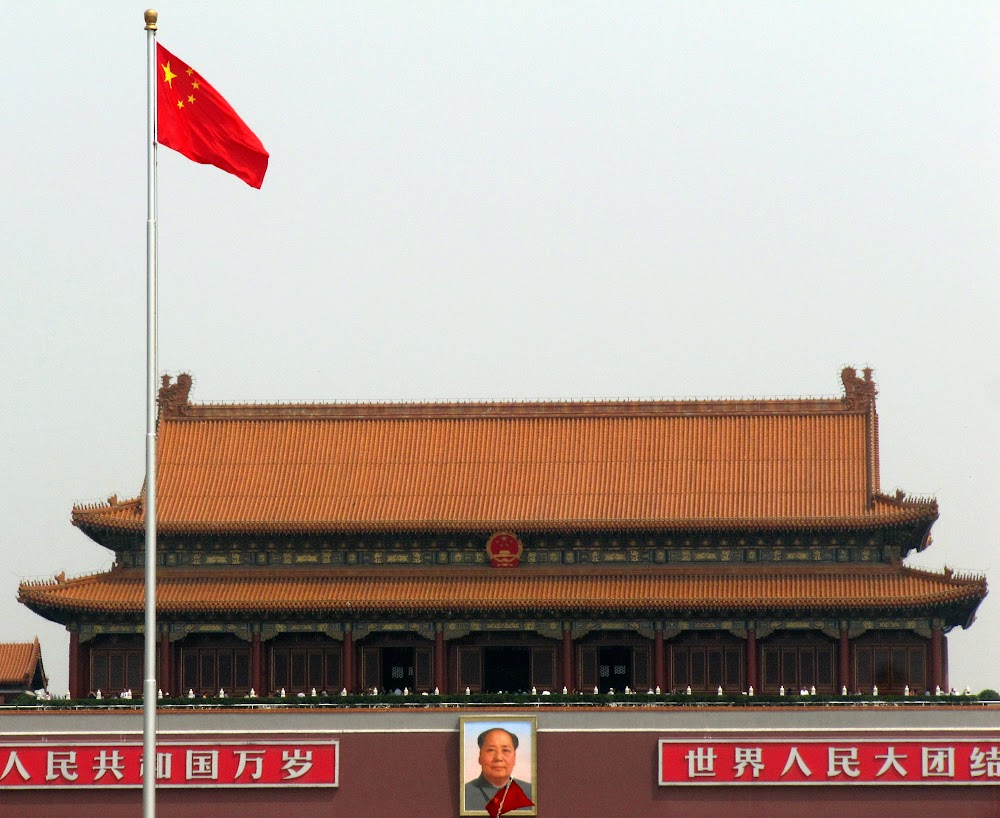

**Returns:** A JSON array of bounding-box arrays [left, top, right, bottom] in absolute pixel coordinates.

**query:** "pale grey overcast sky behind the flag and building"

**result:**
[[0, 0, 1000, 692]]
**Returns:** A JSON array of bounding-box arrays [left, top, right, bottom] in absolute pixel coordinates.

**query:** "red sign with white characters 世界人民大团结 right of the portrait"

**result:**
[[660, 739, 1000, 786]]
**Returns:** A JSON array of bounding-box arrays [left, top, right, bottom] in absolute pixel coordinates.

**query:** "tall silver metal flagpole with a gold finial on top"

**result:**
[[142, 9, 158, 818]]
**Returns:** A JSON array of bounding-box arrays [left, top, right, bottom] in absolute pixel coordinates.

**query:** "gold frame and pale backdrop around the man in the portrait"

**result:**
[[458, 715, 538, 816]]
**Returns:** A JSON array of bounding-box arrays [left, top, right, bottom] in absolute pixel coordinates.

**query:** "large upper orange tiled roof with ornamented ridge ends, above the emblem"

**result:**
[[73, 369, 937, 538]]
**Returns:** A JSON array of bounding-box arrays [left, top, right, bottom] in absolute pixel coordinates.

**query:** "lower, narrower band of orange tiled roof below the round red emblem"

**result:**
[[19, 565, 986, 625]]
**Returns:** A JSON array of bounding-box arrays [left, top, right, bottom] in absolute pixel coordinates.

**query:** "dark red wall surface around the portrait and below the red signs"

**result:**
[[0, 731, 1000, 818]]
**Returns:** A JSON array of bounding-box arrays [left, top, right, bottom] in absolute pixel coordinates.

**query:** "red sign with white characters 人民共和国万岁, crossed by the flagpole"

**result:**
[[0, 741, 340, 790]]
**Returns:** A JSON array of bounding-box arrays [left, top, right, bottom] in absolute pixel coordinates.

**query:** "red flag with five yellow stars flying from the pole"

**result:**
[[156, 43, 268, 188]]
